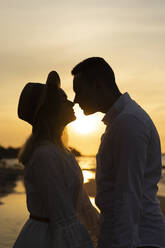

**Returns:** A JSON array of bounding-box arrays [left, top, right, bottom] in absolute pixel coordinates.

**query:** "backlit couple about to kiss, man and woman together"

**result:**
[[14, 57, 165, 248]]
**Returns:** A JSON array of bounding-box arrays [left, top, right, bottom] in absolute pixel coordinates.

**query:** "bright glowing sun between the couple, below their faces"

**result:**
[[70, 104, 98, 134]]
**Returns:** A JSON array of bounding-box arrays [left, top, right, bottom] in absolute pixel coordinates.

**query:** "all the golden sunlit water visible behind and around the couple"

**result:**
[[0, 156, 165, 248]]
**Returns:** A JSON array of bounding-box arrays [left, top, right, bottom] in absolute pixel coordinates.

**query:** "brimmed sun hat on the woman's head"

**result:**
[[18, 71, 60, 126]]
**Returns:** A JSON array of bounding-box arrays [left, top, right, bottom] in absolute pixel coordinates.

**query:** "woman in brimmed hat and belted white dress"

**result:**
[[14, 71, 99, 248]]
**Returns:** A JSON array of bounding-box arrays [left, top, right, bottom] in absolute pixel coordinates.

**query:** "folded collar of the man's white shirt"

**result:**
[[102, 92, 132, 125]]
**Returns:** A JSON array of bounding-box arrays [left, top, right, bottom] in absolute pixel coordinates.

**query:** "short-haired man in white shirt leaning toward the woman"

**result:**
[[72, 57, 165, 248]]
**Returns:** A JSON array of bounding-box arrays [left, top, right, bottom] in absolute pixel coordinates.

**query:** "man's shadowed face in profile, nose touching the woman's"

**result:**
[[73, 74, 99, 115]]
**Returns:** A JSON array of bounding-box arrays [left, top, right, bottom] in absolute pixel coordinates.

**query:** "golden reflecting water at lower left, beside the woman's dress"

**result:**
[[0, 181, 28, 248]]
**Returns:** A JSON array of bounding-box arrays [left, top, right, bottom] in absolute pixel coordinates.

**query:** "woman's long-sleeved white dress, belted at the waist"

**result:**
[[13, 143, 97, 248]]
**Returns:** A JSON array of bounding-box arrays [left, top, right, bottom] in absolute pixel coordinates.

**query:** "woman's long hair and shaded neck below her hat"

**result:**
[[18, 90, 66, 165]]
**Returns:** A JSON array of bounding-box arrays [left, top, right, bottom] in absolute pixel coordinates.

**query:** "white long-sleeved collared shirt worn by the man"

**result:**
[[96, 93, 165, 248]]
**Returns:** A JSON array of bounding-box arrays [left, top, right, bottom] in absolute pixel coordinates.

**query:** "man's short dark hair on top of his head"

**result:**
[[71, 57, 118, 91]]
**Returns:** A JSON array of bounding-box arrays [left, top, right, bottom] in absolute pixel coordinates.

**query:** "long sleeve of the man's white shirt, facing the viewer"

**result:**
[[96, 115, 149, 248]]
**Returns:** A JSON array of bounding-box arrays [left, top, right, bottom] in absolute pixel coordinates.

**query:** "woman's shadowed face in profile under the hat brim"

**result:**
[[59, 88, 76, 126]]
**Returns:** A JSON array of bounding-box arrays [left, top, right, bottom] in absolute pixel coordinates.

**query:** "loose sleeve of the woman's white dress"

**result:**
[[33, 149, 75, 227]]
